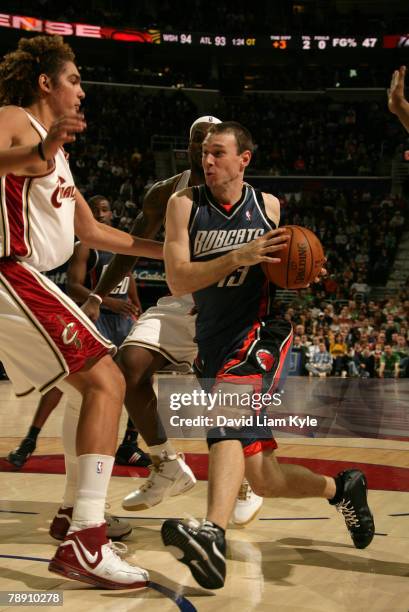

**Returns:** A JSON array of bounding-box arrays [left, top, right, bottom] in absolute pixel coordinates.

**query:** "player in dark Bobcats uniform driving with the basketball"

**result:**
[[162, 122, 374, 589]]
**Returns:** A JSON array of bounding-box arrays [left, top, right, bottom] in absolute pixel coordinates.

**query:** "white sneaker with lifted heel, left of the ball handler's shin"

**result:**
[[122, 455, 196, 511]]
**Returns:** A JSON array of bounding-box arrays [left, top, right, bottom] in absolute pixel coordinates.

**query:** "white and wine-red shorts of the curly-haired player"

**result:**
[[0, 258, 116, 395]]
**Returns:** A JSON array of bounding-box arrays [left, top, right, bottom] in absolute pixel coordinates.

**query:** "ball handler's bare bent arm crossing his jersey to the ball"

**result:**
[[164, 189, 288, 295]]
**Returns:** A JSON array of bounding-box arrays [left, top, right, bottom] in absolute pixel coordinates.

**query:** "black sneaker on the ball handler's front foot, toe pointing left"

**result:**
[[161, 519, 226, 589]]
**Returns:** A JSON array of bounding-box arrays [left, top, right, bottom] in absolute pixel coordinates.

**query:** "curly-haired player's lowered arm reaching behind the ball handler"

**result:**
[[75, 191, 163, 259]]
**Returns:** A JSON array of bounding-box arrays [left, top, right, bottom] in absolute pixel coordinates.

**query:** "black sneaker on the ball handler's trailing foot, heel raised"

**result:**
[[330, 470, 375, 548]]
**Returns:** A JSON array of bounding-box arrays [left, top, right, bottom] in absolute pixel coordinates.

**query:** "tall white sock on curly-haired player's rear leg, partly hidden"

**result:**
[[62, 399, 81, 508]]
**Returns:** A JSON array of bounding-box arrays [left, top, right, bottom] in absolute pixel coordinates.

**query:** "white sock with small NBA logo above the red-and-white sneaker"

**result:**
[[69, 455, 114, 533]]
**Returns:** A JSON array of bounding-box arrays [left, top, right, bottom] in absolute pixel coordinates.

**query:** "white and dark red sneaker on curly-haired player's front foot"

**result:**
[[48, 523, 149, 589]]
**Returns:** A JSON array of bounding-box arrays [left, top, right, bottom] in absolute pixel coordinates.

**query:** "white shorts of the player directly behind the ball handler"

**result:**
[[121, 295, 197, 372]]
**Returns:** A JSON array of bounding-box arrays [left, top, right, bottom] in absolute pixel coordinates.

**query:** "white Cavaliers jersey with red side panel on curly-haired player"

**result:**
[[0, 109, 75, 272]]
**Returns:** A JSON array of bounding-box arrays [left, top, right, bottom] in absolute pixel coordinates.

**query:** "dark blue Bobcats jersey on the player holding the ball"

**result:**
[[189, 184, 276, 350]]
